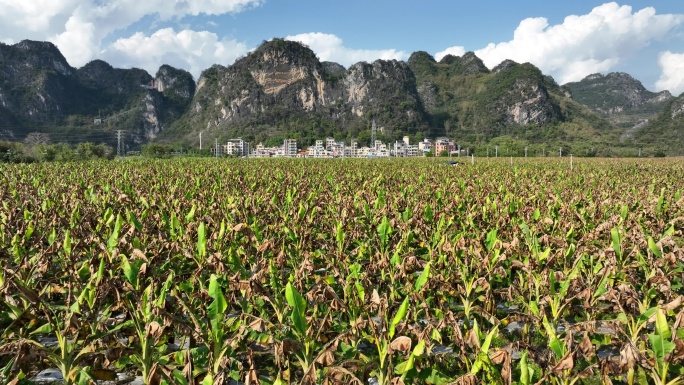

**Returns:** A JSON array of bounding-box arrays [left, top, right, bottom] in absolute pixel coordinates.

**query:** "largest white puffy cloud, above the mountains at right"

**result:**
[[454, 2, 684, 84]]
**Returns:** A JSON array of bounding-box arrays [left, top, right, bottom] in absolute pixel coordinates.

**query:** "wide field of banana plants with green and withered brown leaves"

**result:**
[[0, 158, 684, 385]]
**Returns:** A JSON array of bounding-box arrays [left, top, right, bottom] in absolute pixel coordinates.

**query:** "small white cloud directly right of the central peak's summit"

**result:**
[[285, 32, 408, 67]]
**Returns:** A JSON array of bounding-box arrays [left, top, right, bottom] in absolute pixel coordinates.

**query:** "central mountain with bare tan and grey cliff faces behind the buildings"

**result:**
[[172, 39, 425, 144]]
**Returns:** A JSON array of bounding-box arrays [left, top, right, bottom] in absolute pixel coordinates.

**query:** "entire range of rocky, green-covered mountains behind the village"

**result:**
[[0, 39, 674, 154]]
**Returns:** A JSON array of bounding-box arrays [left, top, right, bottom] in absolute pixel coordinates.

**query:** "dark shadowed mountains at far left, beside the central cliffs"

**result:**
[[0, 40, 194, 143]]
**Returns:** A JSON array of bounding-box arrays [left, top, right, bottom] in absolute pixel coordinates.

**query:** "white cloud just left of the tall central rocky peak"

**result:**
[[102, 28, 248, 79]]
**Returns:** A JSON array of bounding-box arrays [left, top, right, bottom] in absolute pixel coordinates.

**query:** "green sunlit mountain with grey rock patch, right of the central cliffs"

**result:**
[[408, 52, 617, 155]]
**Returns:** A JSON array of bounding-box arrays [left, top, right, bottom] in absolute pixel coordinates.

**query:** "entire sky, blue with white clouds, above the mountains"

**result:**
[[0, 0, 684, 95]]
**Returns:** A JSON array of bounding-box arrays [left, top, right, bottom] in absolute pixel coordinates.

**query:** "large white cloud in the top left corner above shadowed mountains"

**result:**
[[0, 0, 264, 67]]
